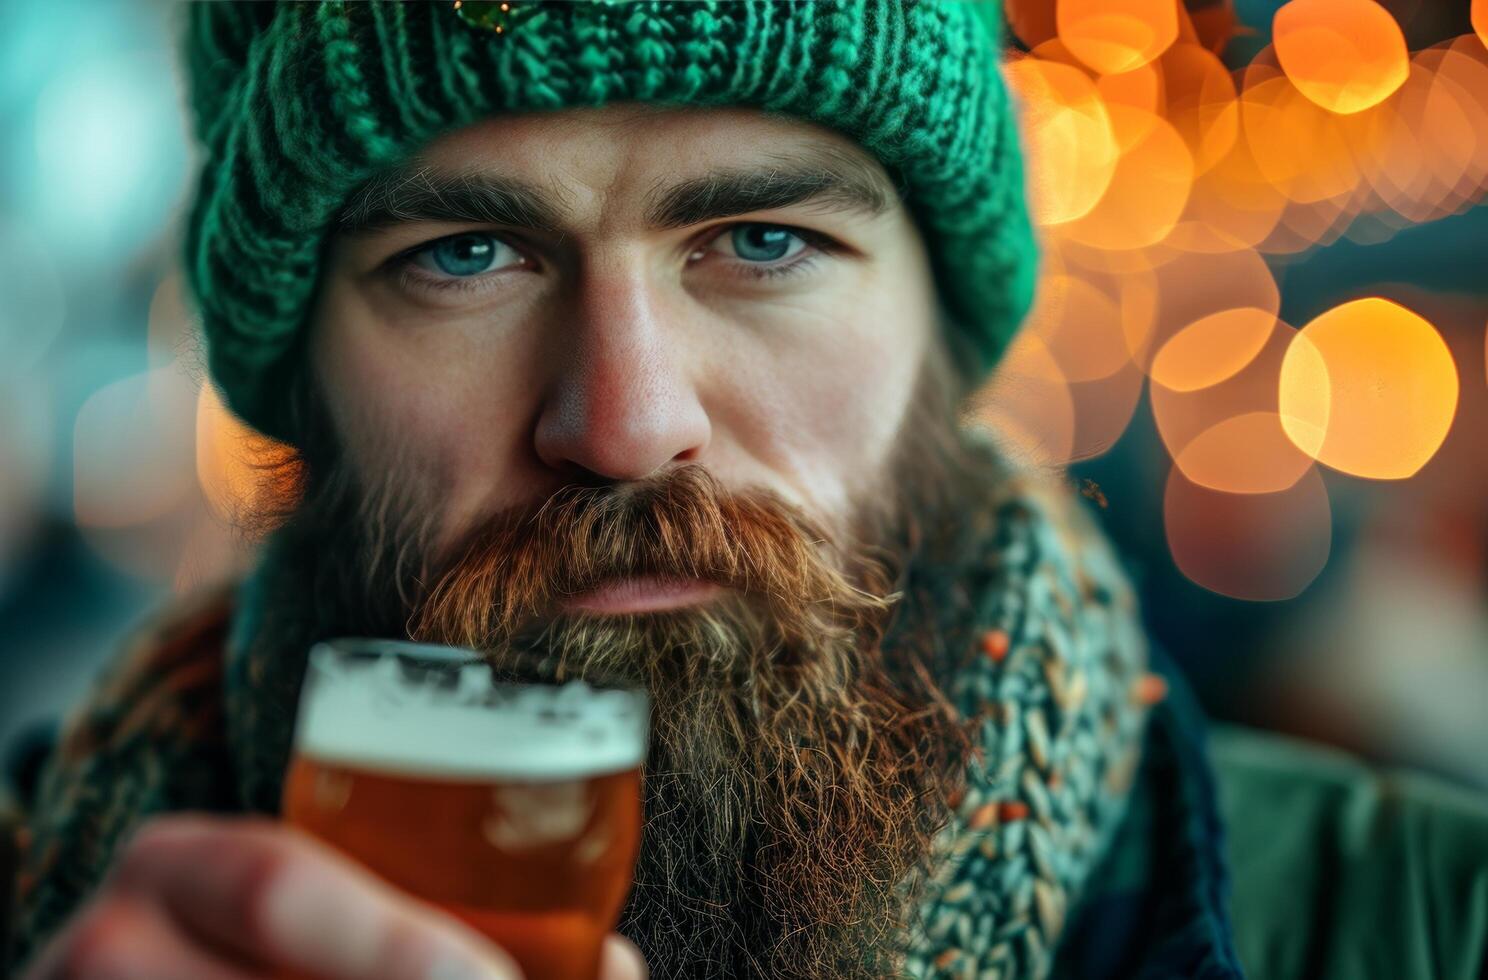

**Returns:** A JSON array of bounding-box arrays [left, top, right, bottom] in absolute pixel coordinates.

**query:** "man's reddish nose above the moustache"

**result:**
[[534, 280, 710, 480]]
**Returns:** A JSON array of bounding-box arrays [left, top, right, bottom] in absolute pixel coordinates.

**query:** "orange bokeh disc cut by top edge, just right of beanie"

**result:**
[[1054, 0, 1178, 74]]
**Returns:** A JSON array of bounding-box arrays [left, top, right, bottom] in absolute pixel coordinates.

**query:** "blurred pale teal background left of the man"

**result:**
[[0, 1, 231, 767]]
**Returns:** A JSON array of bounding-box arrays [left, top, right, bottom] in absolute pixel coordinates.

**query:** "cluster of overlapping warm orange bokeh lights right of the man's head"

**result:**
[[969, 0, 1488, 599]]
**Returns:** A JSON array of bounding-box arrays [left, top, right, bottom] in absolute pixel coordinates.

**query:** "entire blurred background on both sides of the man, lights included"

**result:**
[[0, 0, 1488, 788]]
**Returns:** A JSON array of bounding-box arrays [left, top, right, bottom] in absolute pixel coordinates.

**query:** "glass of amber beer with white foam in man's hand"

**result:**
[[284, 639, 649, 980]]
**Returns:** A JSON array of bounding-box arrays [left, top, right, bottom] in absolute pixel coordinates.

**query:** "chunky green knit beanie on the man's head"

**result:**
[[183, 0, 1036, 442]]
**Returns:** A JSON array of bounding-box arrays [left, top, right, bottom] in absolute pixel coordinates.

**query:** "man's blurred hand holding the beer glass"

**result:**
[[24, 815, 646, 980]]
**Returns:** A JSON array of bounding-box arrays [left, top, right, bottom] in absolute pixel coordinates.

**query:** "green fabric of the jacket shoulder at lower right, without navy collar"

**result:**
[[1211, 730, 1488, 980]]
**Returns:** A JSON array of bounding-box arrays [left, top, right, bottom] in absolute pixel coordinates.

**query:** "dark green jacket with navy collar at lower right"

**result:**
[[1055, 653, 1488, 980]]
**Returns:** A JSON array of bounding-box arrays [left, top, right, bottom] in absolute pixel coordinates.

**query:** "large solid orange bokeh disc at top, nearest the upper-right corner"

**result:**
[[1272, 0, 1409, 115]]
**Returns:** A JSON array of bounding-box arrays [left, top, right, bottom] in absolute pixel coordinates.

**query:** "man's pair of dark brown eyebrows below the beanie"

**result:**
[[338, 147, 905, 236]]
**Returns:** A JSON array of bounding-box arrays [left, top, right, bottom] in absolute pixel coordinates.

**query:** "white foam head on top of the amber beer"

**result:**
[[295, 639, 649, 781]]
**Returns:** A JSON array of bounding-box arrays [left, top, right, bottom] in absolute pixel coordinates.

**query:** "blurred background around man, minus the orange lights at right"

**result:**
[[0, 0, 1488, 788]]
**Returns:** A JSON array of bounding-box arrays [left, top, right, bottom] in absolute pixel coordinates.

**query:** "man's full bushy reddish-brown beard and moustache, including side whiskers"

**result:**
[[244, 340, 988, 977]]
